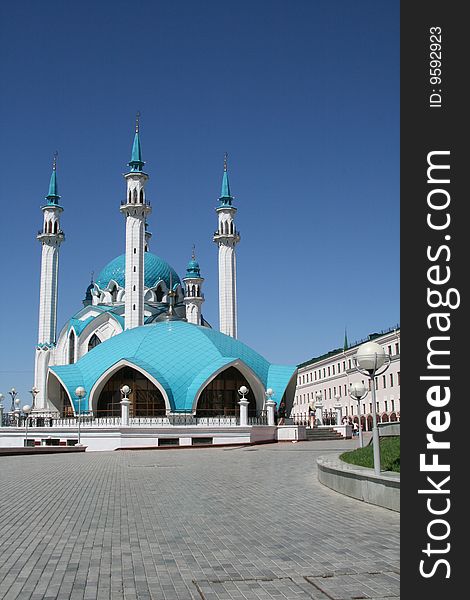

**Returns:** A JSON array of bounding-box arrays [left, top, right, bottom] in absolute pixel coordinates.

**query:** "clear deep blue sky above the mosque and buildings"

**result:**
[[0, 0, 399, 400]]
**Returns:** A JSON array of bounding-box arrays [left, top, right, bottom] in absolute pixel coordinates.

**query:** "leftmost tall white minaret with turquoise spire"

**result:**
[[34, 153, 65, 410]]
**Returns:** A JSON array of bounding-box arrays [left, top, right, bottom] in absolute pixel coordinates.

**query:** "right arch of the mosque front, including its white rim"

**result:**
[[193, 360, 264, 416]]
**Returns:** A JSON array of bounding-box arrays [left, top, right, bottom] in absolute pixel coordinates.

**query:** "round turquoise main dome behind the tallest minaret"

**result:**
[[95, 252, 181, 290]]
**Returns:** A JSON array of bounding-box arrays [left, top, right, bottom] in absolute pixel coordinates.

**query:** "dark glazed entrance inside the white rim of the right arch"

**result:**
[[196, 367, 256, 417]]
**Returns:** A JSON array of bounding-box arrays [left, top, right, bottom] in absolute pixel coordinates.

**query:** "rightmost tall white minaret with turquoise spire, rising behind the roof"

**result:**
[[213, 154, 240, 338]]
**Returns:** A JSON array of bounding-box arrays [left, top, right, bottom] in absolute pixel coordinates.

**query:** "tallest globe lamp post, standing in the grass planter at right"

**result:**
[[353, 342, 390, 475]]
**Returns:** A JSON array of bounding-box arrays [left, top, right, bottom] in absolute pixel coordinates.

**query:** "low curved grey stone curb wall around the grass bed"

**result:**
[[317, 452, 400, 512]]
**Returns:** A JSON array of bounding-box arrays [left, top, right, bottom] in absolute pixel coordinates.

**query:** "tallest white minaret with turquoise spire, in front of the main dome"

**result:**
[[120, 115, 152, 329]]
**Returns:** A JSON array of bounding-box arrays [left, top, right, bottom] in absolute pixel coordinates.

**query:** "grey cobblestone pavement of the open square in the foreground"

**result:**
[[0, 442, 399, 600]]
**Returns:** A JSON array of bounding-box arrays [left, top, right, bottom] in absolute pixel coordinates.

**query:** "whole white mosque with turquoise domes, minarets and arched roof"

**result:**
[[34, 120, 296, 417]]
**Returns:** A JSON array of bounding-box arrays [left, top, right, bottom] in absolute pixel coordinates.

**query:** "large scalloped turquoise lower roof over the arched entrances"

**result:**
[[51, 321, 296, 411]]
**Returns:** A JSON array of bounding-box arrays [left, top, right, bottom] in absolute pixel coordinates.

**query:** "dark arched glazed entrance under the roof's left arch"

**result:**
[[96, 367, 166, 417]]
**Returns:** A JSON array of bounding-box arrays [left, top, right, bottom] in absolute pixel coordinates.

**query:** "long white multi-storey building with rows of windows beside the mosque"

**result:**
[[291, 326, 400, 431]]
